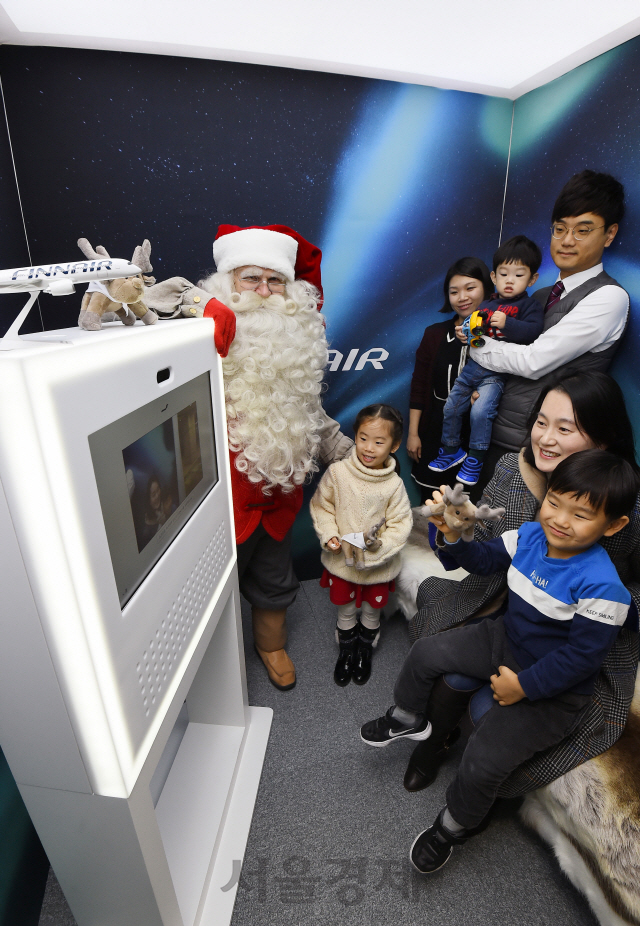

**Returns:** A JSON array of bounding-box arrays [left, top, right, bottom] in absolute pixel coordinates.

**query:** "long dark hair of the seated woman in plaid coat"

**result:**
[[524, 373, 640, 472]]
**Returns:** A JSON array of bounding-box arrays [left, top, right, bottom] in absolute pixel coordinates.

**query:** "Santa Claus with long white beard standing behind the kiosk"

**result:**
[[146, 225, 353, 691]]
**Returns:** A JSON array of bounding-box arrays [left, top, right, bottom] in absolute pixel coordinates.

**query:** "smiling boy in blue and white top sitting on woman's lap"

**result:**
[[361, 450, 638, 874]]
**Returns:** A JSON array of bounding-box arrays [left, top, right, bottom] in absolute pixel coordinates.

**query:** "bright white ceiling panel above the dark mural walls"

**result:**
[[0, 0, 640, 99]]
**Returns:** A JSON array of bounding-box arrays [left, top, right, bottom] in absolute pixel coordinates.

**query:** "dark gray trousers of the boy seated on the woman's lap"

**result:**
[[394, 617, 591, 829]]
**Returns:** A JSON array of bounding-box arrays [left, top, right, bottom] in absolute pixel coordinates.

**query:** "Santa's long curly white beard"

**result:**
[[199, 274, 328, 494]]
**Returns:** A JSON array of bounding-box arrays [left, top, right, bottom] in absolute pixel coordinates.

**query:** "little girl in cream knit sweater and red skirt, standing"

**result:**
[[311, 405, 411, 686]]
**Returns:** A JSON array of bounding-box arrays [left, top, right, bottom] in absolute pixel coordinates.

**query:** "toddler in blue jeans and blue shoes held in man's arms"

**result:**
[[429, 235, 544, 485]]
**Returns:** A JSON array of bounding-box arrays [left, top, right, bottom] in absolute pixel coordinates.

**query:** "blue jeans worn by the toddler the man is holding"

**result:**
[[442, 360, 505, 450]]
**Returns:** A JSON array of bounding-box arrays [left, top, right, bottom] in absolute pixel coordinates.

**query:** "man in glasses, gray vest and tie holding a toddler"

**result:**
[[471, 170, 629, 472]]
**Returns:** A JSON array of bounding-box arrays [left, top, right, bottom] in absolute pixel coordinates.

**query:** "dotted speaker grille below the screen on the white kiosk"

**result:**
[[136, 522, 231, 717]]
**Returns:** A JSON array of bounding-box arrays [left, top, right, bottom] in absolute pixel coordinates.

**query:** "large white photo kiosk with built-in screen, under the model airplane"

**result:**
[[0, 302, 272, 926]]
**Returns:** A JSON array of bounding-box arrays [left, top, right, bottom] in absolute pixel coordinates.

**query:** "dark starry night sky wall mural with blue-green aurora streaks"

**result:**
[[0, 40, 640, 577]]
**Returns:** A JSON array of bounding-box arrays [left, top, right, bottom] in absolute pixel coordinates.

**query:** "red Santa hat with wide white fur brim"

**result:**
[[213, 225, 322, 296]]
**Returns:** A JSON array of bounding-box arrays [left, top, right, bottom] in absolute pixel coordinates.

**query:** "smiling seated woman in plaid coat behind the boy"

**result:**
[[405, 373, 640, 797]]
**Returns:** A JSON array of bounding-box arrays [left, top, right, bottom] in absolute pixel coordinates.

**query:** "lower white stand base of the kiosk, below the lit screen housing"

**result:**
[[20, 568, 273, 926]]
